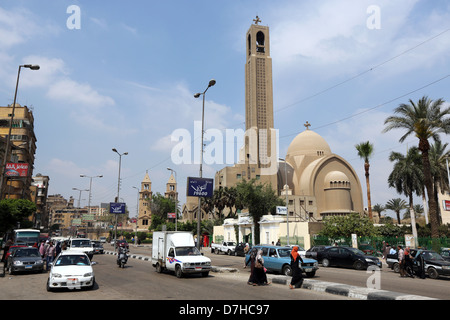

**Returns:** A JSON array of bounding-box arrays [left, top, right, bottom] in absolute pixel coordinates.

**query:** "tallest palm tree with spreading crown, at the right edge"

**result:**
[[383, 96, 450, 238]]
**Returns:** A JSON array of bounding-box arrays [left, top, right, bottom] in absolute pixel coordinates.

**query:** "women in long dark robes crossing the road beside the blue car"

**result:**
[[244, 245, 303, 289]]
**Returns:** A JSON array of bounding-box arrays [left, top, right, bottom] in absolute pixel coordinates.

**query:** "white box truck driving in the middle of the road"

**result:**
[[152, 231, 211, 278]]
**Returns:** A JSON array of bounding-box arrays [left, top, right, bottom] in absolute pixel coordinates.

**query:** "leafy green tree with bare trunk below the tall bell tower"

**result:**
[[236, 179, 284, 244]]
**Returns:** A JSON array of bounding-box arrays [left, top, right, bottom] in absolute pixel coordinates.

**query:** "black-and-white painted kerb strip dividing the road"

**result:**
[[105, 246, 437, 300]]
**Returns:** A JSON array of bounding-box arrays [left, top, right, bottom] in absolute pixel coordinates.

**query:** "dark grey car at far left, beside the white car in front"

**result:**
[[6, 247, 44, 274]]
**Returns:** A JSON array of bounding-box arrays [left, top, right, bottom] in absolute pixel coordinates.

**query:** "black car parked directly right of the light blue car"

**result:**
[[322, 247, 382, 270]]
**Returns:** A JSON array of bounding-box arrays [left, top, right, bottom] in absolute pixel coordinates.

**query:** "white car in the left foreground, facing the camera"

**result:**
[[47, 251, 96, 291]]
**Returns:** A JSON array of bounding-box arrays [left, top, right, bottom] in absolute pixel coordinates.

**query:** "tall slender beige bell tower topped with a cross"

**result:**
[[244, 16, 276, 168]]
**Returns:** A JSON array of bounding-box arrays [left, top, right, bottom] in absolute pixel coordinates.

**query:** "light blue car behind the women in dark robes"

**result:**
[[245, 245, 319, 277]]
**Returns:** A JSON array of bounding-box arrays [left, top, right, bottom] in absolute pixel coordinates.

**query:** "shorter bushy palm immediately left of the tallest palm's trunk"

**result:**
[[388, 147, 423, 248]]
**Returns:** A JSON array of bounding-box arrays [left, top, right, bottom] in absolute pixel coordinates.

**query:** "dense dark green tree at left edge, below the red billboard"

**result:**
[[0, 199, 36, 233]]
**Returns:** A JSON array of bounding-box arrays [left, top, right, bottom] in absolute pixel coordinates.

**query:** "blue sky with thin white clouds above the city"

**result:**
[[0, 0, 450, 220]]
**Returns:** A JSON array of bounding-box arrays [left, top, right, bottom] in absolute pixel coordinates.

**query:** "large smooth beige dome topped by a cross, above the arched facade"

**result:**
[[287, 130, 331, 156]]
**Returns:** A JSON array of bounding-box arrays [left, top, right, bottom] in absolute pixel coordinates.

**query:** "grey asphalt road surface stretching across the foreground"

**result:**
[[0, 244, 450, 301]]
